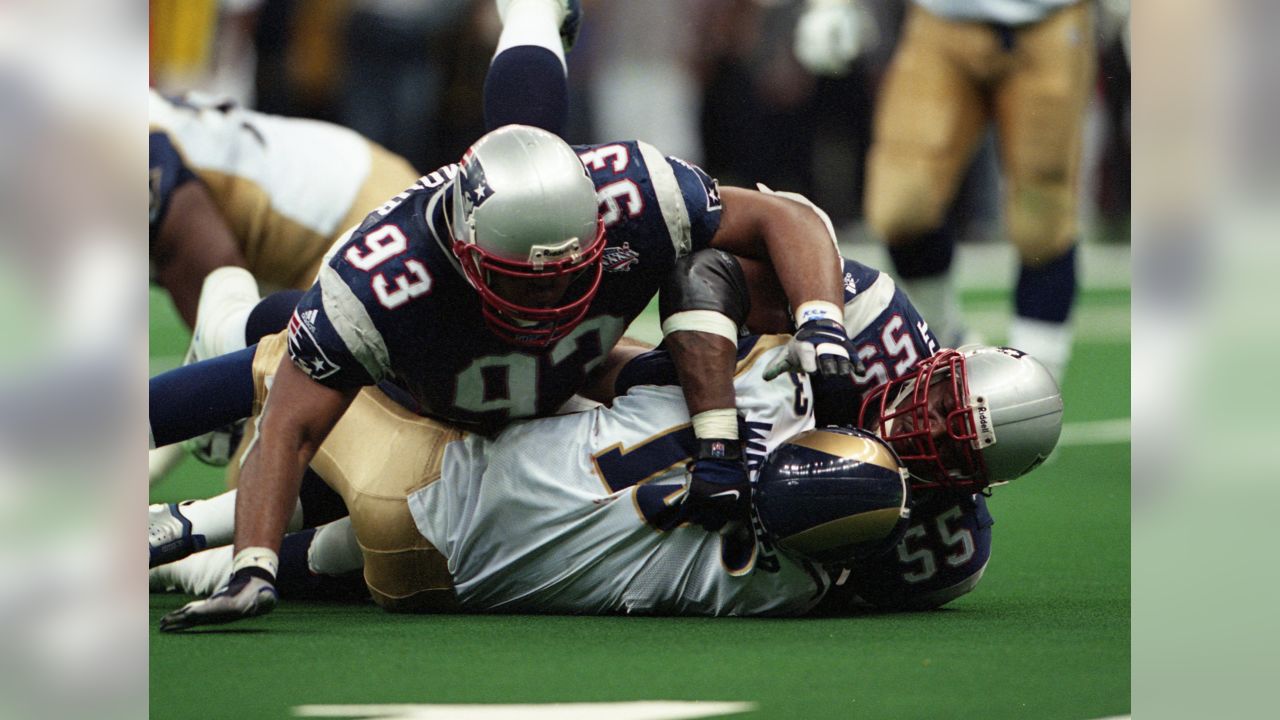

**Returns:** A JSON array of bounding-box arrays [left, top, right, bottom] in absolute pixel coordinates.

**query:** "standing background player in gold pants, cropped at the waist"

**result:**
[[797, 0, 1096, 378]]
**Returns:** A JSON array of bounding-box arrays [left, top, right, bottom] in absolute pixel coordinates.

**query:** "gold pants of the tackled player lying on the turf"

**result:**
[[253, 331, 463, 612]]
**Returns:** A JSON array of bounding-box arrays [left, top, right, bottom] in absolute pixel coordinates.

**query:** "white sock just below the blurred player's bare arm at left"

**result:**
[[188, 266, 260, 361]]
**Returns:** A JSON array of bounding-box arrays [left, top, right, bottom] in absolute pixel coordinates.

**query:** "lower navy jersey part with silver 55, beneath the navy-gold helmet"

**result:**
[[828, 493, 993, 610]]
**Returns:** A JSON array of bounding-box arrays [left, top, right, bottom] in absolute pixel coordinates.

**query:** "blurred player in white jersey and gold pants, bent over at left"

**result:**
[[148, 90, 419, 330]]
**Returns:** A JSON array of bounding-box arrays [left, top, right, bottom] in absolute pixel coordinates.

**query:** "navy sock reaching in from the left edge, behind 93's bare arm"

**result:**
[[147, 346, 257, 447]]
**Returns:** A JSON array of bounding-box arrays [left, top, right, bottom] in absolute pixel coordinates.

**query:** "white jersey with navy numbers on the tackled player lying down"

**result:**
[[408, 336, 829, 615]]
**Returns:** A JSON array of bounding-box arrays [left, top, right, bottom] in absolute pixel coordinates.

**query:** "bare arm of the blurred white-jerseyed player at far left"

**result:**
[[151, 181, 246, 327]]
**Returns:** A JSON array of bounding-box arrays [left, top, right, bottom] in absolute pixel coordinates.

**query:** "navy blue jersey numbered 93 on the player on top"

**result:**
[[289, 141, 721, 432]]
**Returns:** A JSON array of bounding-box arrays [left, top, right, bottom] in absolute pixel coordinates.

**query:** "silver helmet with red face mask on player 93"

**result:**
[[449, 126, 605, 345]]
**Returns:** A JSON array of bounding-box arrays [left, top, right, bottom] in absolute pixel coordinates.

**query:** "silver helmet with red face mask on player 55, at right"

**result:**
[[859, 345, 1062, 492]]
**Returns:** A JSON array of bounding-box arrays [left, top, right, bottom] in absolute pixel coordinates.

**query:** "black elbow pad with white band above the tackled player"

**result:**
[[658, 250, 751, 343]]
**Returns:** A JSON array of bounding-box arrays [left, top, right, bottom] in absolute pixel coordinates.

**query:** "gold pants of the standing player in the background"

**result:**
[[865, 1, 1096, 266]]
